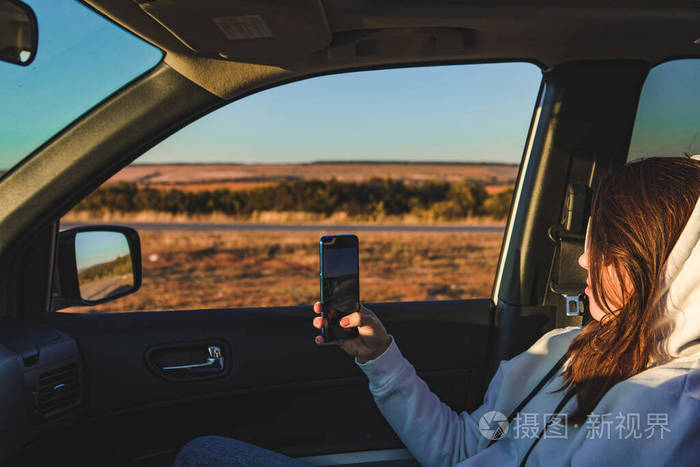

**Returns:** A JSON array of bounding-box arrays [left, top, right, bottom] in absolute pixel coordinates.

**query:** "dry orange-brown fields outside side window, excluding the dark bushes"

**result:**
[[62, 163, 508, 312]]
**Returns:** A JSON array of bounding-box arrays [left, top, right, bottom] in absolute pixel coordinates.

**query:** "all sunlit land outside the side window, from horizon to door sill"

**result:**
[[63, 163, 508, 312]]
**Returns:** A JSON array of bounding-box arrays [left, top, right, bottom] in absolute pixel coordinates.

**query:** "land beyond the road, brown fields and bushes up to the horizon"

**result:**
[[64, 163, 516, 224]]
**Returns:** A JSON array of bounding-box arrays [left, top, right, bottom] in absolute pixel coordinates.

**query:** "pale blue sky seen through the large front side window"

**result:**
[[139, 63, 541, 162]]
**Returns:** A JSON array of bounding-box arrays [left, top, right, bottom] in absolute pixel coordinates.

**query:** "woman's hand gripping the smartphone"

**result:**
[[313, 302, 391, 363]]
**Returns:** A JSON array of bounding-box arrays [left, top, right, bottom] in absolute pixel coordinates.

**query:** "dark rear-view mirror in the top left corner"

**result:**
[[0, 0, 39, 66]]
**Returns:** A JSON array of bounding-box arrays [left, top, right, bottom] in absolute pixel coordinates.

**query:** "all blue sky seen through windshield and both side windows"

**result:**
[[0, 0, 700, 170]]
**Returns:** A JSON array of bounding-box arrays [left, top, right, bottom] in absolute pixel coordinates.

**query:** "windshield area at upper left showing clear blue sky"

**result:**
[[0, 0, 163, 177]]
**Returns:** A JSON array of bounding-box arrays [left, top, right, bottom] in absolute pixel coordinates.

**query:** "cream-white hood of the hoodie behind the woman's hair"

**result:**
[[660, 156, 700, 357]]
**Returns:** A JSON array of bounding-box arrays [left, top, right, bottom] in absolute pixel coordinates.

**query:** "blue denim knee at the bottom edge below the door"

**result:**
[[174, 436, 308, 467]]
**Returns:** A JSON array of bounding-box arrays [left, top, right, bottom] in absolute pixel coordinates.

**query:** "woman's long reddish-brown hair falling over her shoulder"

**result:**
[[562, 157, 700, 424]]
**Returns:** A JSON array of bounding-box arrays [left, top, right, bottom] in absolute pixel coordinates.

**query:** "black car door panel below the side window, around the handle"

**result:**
[[31, 300, 493, 460]]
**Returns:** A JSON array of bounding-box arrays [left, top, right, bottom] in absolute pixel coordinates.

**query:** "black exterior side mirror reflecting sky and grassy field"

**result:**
[[52, 226, 141, 311]]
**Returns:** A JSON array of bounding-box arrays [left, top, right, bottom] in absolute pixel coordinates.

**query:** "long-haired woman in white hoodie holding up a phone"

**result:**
[[178, 158, 700, 466]]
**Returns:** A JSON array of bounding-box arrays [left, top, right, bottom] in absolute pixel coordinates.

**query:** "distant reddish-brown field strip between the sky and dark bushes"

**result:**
[[108, 162, 518, 191]]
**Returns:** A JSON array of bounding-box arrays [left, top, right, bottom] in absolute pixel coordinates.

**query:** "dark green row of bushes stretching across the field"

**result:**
[[74, 178, 513, 220]]
